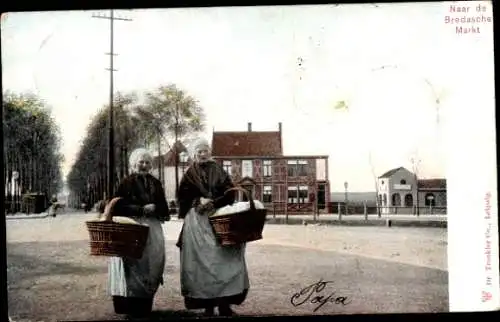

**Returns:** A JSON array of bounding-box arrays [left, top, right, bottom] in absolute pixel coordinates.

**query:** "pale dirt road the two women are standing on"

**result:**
[[7, 214, 448, 321]]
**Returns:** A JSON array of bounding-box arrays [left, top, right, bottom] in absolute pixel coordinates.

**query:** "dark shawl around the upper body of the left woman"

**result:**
[[115, 173, 170, 221]]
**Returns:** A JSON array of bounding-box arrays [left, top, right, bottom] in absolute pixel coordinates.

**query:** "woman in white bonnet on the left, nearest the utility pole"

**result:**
[[105, 148, 170, 316]]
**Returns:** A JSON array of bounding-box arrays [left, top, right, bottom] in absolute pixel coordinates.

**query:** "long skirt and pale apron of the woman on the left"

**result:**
[[108, 217, 165, 298]]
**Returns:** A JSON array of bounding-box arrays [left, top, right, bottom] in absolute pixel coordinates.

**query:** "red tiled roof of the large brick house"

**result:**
[[212, 131, 283, 157]]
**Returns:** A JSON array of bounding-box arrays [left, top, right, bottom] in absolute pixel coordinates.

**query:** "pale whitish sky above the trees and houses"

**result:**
[[1, 1, 494, 191]]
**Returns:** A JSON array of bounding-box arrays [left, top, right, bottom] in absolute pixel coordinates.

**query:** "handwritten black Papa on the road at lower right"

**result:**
[[290, 279, 351, 312]]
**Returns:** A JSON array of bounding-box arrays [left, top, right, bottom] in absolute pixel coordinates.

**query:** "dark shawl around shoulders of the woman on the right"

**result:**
[[177, 161, 236, 218]]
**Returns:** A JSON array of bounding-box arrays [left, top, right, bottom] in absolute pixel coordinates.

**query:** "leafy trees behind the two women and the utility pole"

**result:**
[[67, 84, 205, 208]]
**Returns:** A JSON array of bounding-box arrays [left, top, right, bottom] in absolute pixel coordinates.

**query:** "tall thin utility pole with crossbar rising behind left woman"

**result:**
[[92, 9, 132, 198]]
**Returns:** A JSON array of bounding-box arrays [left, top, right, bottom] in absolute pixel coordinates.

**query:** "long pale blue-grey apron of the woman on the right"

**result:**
[[181, 208, 249, 299]]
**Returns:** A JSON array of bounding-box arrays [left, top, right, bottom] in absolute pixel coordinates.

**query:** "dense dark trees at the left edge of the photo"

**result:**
[[2, 92, 63, 211]]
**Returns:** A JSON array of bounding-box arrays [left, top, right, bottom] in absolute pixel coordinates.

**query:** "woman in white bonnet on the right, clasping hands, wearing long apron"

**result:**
[[177, 139, 249, 316]]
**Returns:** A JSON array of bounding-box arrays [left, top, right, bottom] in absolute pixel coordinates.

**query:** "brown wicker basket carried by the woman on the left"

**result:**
[[86, 198, 149, 259]]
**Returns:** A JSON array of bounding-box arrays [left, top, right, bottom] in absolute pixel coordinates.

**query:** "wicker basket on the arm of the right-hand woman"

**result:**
[[209, 187, 267, 246]]
